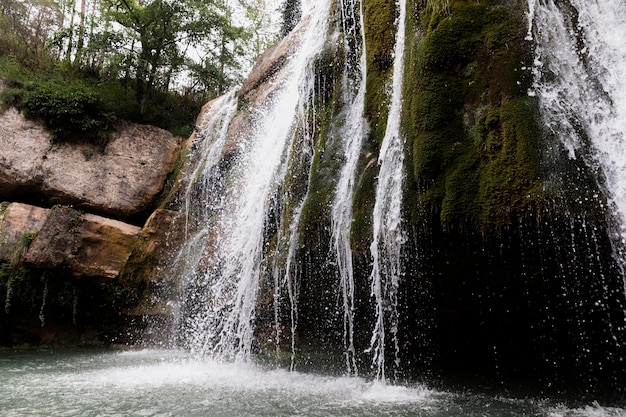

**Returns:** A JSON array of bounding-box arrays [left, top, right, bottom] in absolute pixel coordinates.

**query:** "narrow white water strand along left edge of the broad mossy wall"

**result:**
[[369, 0, 406, 381]]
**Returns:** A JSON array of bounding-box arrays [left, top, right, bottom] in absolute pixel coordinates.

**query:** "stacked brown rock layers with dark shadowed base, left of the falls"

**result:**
[[0, 102, 181, 346]]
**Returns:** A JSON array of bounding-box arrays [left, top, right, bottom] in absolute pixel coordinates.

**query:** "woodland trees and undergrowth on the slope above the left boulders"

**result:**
[[0, 0, 275, 138]]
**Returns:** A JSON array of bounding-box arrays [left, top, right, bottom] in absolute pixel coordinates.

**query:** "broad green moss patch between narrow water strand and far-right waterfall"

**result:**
[[403, 1, 541, 233]]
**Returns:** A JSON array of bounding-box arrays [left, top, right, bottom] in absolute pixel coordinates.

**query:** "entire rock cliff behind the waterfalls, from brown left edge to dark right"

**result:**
[[160, 0, 626, 394]]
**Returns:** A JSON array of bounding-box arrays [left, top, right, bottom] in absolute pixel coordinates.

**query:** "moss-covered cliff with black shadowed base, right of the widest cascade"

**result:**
[[259, 0, 624, 388]]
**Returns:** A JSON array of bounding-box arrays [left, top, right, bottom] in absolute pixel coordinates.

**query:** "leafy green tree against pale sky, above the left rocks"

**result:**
[[104, 0, 245, 103]]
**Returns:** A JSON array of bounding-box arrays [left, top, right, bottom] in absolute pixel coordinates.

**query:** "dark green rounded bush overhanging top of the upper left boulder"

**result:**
[[21, 82, 113, 142]]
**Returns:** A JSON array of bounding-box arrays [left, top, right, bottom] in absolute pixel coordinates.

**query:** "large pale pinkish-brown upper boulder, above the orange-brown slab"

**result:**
[[0, 109, 180, 219]]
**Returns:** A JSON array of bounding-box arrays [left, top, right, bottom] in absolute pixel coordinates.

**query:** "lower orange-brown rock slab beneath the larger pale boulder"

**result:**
[[0, 203, 141, 279]]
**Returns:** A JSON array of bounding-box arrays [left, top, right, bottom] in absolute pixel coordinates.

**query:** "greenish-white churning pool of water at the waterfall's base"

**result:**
[[0, 350, 626, 417]]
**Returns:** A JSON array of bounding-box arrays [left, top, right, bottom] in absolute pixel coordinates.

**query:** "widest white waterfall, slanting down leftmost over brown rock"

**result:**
[[169, 1, 329, 359]]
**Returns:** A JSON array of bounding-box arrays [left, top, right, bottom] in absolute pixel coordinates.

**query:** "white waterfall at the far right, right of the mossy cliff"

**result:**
[[528, 0, 626, 274]]
